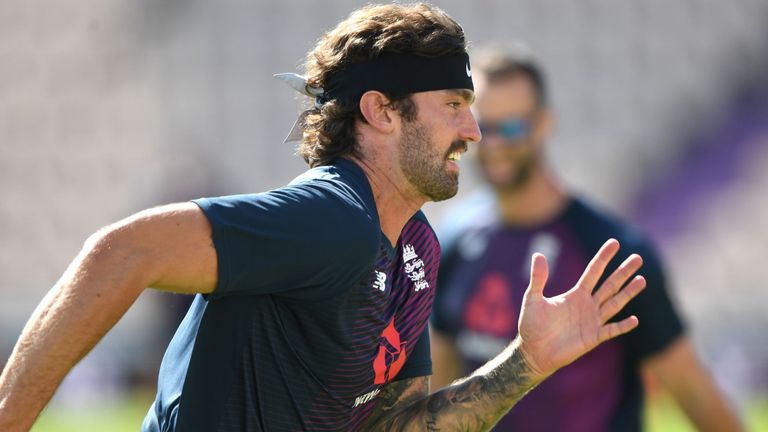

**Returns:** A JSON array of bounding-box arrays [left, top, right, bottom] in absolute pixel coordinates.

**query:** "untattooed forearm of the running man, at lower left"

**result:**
[[0, 231, 149, 431]]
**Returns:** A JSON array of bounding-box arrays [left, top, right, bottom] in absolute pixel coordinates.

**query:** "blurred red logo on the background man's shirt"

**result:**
[[464, 273, 517, 337]]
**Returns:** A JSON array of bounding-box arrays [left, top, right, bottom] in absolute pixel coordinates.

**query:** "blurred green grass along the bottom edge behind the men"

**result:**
[[32, 395, 768, 432]]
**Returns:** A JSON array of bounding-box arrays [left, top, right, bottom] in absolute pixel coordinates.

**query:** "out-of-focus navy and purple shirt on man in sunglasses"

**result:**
[[433, 195, 683, 432]]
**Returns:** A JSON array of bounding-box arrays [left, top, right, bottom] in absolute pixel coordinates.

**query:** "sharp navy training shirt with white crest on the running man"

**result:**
[[142, 159, 440, 431]]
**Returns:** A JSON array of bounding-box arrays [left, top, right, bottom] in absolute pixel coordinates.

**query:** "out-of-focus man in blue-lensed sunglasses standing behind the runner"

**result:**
[[432, 47, 741, 432]]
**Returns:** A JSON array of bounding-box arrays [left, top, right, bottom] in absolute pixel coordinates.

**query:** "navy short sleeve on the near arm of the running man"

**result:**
[[194, 184, 379, 300]]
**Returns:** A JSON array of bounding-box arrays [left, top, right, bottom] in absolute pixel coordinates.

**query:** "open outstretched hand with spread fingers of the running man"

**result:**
[[518, 239, 645, 378]]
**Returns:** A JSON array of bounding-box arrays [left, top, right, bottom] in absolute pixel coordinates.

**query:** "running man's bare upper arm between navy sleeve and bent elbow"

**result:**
[[95, 202, 217, 294]]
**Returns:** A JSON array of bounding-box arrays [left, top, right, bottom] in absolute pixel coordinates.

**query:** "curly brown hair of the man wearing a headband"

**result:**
[[298, 3, 467, 167]]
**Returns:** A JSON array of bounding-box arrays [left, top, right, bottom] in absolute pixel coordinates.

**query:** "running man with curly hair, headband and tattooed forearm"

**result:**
[[0, 4, 644, 431]]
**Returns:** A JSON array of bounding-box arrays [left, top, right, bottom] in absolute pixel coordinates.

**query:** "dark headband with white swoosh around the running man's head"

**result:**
[[318, 53, 474, 103]]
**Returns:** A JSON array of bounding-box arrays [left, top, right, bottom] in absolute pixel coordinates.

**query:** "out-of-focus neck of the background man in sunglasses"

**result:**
[[496, 167, 569, 227]]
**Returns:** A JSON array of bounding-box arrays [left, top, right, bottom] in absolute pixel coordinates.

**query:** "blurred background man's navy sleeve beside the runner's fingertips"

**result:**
[[618, 241, 684, 360]]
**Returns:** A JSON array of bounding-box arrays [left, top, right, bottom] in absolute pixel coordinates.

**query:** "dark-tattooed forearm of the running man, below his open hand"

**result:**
[[366, 347, 539, 431]]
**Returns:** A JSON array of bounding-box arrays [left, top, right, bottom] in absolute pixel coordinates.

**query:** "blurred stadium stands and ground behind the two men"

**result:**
[[0, 0, 768, 431]]
